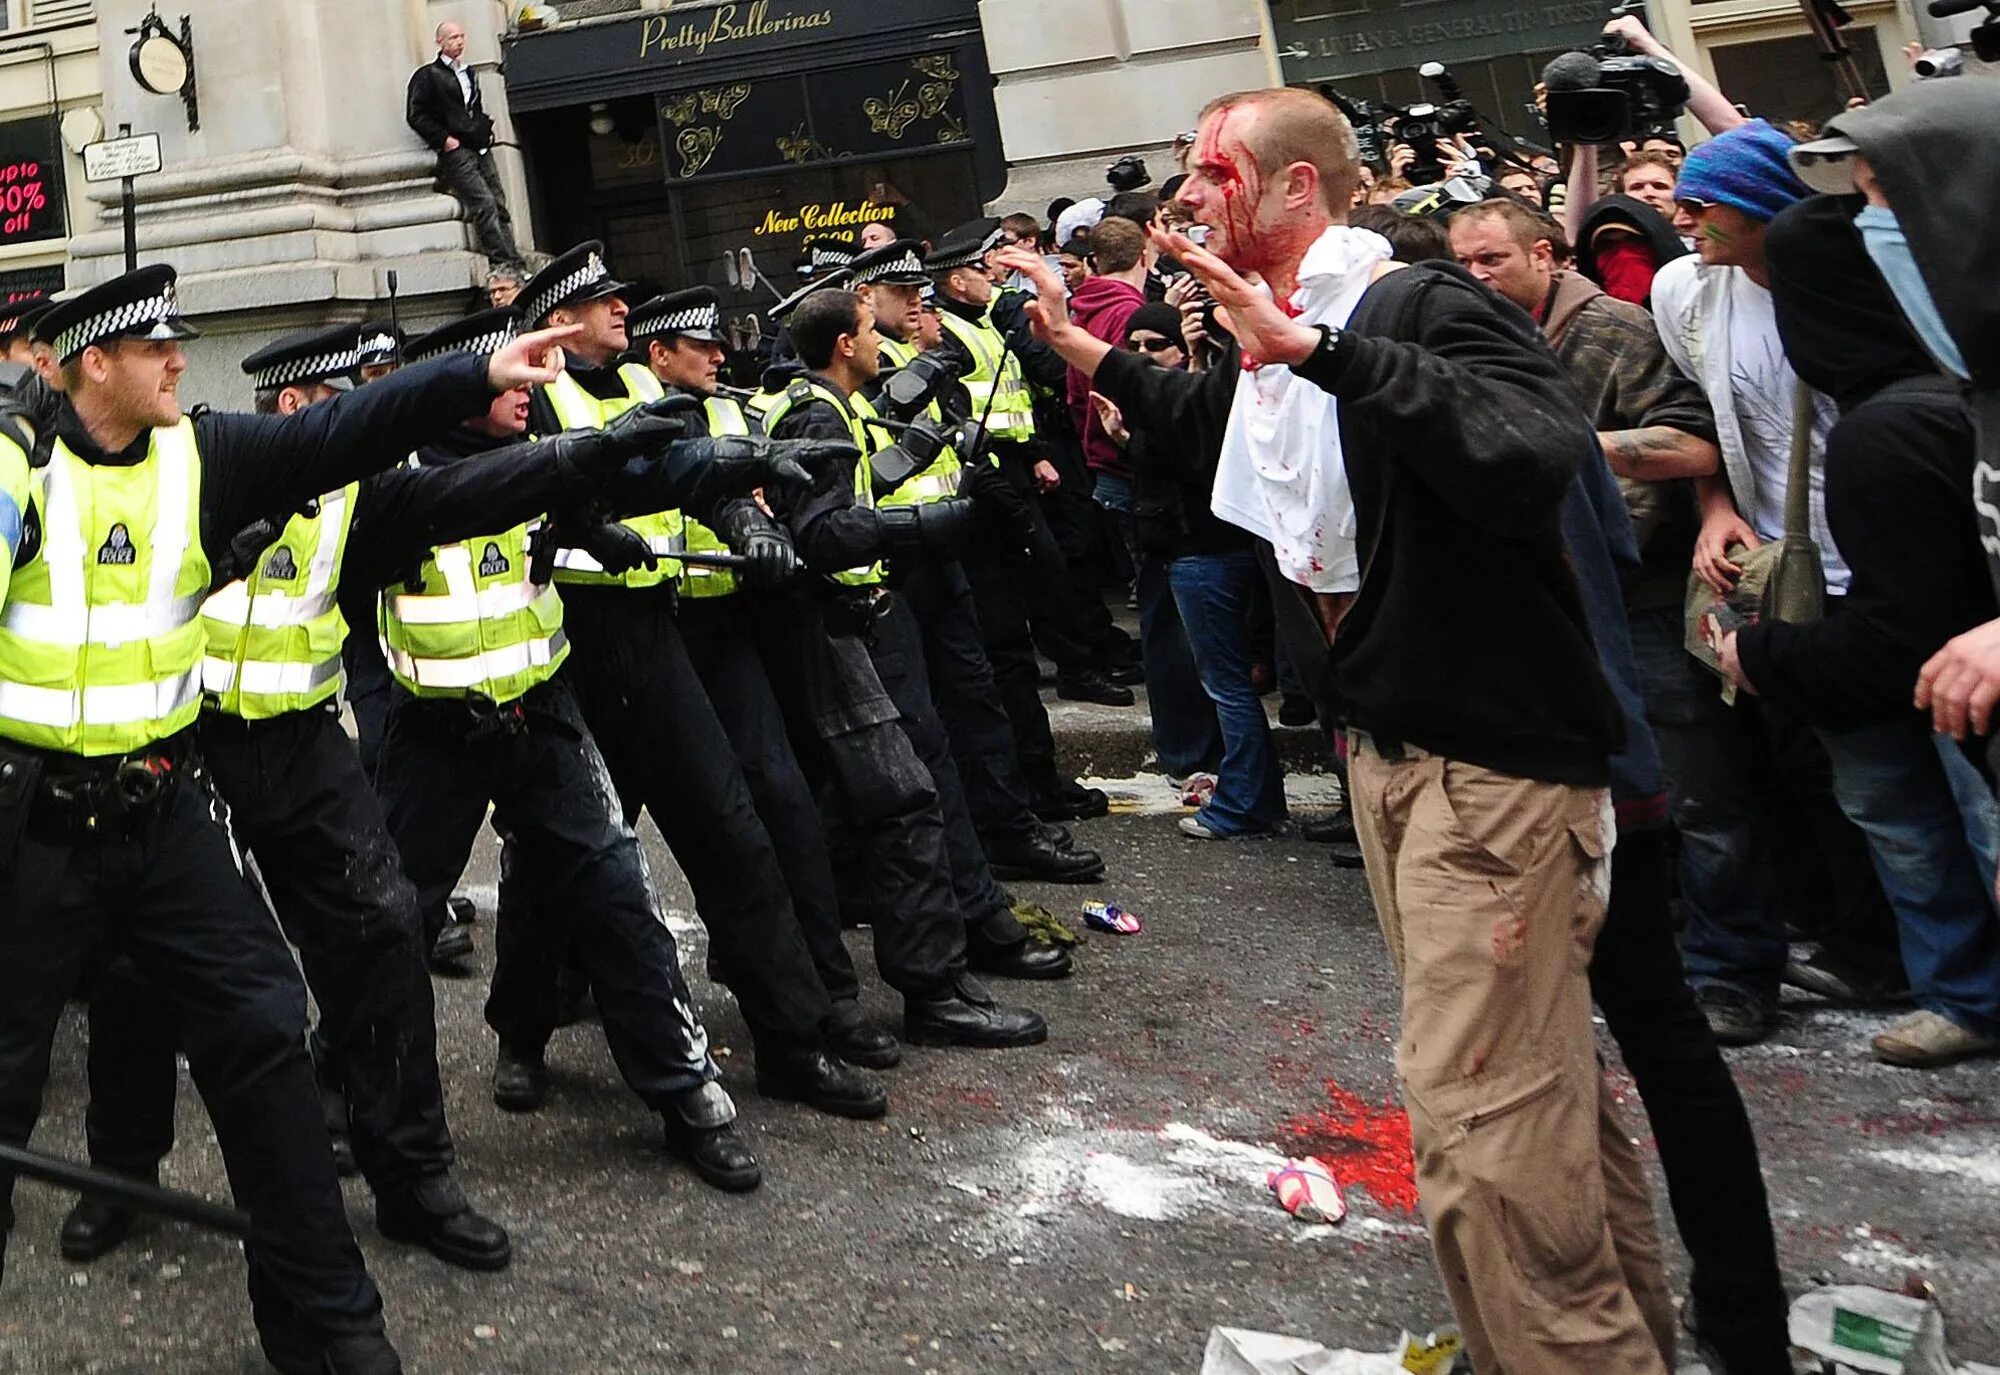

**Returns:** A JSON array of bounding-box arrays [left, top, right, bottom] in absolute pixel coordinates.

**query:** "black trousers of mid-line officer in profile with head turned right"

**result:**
[[746, 592, 966, 997]]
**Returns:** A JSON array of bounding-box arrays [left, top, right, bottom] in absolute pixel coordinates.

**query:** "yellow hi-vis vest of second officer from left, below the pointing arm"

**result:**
[[202, 484, 360, 721]]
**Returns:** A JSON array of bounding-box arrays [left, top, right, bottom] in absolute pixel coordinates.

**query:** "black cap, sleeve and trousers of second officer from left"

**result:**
[[66, 328, 624, 1269]]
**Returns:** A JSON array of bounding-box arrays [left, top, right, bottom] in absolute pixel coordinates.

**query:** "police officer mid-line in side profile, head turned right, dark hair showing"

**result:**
[[766, 276, 1068, 1047]]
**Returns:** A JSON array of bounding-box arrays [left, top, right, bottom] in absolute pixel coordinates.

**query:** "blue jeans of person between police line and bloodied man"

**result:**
[[1166, 550, 1284, 835]]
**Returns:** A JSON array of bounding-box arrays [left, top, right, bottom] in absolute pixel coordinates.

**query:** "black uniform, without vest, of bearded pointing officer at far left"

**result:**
[[0, 270, 504, 1373]]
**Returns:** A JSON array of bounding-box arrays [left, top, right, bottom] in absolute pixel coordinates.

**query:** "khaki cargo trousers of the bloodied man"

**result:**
[[1350, 733, 1674, 1375]]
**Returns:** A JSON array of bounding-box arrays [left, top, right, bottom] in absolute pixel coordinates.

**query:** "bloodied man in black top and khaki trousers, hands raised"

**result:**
[[1000, 90, 1674, 1375]]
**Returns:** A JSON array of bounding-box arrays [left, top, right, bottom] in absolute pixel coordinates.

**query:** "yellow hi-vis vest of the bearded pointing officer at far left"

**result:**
[[0, 420, 210, 755]]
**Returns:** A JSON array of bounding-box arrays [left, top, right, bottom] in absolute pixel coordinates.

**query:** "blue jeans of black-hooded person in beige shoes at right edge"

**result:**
[[1820, 711, 2000, 1035]]
